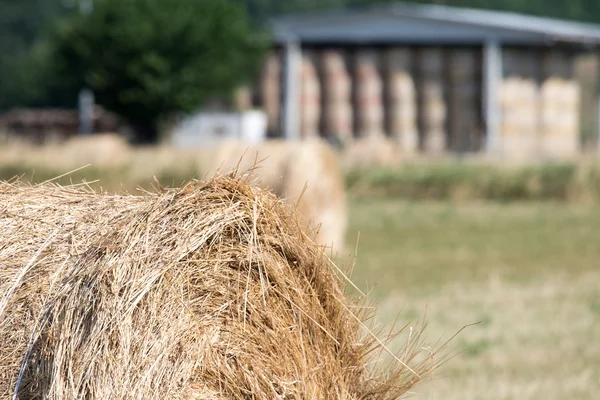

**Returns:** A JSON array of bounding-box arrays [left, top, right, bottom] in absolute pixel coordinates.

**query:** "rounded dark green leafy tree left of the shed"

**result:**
[[51, 0, 267, 141]]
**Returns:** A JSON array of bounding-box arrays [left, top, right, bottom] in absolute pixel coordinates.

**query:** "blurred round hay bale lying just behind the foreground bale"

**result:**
[[208, 138, 347, 251]]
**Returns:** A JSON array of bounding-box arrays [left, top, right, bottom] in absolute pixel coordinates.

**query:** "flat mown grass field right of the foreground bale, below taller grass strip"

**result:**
[[349, 199, 600, 400]]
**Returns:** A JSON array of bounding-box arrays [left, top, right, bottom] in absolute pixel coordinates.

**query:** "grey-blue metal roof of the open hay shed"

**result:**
[[271, 3, 600, 46]]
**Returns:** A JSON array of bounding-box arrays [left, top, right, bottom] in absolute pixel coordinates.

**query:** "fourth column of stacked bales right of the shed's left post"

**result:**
[[386, 48, 419, 155]]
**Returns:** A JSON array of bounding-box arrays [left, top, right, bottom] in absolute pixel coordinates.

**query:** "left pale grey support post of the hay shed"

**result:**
[[283, 39, 302, 140]]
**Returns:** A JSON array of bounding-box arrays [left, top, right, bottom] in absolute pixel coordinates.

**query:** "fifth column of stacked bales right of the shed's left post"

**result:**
[[419, 48, 447, 155]]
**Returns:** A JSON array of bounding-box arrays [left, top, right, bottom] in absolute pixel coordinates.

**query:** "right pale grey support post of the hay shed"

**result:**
[[483, 39, 502, 154]]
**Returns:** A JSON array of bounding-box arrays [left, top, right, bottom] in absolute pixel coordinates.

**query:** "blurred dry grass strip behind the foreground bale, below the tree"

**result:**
[[0, 134, 203, 192]]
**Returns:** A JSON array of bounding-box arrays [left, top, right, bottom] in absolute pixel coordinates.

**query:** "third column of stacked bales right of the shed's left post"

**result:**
[[354, 49, 383, 138]]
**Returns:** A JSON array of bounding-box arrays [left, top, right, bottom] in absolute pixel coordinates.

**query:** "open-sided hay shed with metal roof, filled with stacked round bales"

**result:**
[[255, 3, 600, 158]]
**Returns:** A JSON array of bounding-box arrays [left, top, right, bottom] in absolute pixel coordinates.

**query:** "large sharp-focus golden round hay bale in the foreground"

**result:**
[[0, 177, 431, 400]]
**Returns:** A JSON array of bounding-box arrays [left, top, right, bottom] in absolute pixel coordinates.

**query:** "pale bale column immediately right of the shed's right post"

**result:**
[[500, 50, 540, 159]]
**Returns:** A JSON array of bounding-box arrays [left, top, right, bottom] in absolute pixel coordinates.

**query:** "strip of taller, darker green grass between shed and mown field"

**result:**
[[346, 162, 600, 201]]
